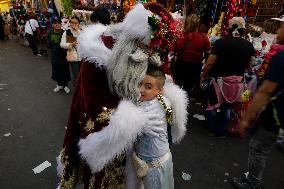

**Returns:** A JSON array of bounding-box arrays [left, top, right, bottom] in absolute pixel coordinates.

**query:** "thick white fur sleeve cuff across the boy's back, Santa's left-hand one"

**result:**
[[79, 100, 146, 173]]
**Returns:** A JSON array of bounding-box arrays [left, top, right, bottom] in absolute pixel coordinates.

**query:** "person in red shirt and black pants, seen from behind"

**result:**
[[174, 14, 211, 95]]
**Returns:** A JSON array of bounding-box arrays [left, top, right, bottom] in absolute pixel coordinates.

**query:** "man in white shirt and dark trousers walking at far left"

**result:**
[[25, 16, 41, 56]]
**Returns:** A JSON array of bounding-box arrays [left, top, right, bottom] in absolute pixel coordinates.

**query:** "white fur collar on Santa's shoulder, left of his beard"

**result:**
[[77, 24, 111, 66]]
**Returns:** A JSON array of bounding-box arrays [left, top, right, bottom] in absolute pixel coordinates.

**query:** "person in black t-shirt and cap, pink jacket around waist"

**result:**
[[200, 17, 255, 138]]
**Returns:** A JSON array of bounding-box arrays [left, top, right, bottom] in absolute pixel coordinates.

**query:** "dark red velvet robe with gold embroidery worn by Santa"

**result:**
[[61, 36, 124, 189]]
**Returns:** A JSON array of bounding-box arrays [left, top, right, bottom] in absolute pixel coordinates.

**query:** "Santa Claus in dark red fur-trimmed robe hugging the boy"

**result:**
[[58, 4, 187, 189]]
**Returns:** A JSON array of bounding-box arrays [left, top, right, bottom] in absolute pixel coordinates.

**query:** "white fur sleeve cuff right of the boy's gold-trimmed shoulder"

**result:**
[[164, 76, 188, 143]]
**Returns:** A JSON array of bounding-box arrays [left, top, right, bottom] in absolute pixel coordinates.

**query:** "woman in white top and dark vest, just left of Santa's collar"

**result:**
[[60, 16, 81, 85]]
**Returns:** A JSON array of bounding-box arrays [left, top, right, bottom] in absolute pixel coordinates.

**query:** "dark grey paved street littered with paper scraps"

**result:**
[[0, 40, 284, 189]]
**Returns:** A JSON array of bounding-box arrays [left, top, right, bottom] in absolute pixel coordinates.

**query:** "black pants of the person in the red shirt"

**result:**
[[174, 62, 202, 95]]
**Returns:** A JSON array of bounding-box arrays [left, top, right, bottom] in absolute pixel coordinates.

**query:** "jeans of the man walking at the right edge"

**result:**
[[248, 126, 278, 187]]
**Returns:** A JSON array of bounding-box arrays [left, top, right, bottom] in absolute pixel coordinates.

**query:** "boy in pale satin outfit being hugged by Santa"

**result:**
[[132, 65, 174, 189]]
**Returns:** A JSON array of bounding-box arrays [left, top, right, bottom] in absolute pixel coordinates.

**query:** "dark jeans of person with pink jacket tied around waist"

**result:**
[[205, 102, 231, 136]]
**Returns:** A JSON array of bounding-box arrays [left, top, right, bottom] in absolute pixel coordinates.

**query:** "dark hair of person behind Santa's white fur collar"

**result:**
[[90, 6, 110, 25]]
